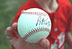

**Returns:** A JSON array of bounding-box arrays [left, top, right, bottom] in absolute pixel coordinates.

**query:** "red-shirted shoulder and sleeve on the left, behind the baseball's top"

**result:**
[[13, 0, 38, 22]]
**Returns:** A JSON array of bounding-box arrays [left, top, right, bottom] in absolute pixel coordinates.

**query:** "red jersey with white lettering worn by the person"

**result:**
[[12, 0, 72, 49]]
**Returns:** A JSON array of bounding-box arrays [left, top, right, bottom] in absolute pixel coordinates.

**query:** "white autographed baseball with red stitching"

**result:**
[[18, 8, 51, 43]]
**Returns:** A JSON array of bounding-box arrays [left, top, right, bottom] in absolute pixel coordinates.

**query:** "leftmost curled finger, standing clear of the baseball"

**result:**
[[6, 27, 17, 46]]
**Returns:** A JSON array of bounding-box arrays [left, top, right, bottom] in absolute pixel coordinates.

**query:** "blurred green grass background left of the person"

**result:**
[[0, 0, 72, 49]]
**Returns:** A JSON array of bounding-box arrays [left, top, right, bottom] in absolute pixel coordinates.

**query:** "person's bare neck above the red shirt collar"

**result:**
[[35, 0, 58, 13]]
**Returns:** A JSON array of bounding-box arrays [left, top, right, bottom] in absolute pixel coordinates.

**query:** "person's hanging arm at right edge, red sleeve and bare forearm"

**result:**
[[65, 0, 72, 49]]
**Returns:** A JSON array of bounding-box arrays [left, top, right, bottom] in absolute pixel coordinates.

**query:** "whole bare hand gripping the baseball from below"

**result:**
[[6, 23, 49, 49]]
